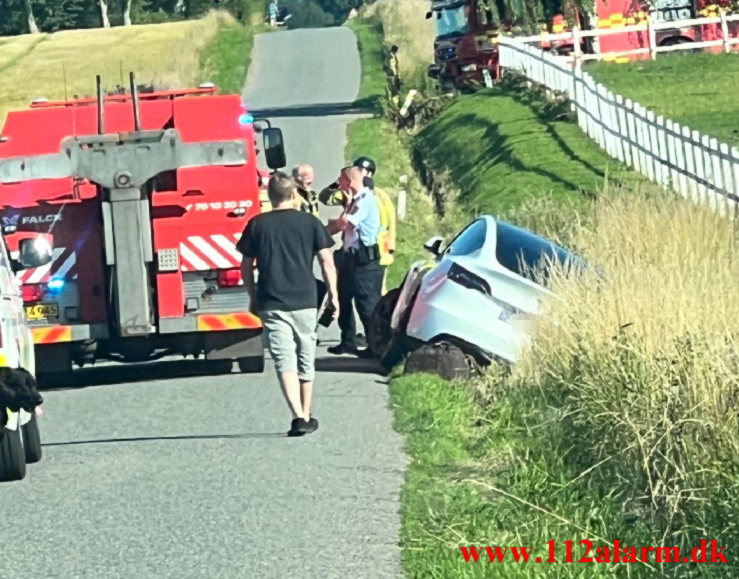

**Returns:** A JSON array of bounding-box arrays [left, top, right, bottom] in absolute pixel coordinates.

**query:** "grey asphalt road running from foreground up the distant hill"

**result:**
[[0, 24, 405, 579]]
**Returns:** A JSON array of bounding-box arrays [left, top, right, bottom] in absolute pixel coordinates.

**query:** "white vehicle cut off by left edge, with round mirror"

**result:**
[[0, 235, 52, 481]]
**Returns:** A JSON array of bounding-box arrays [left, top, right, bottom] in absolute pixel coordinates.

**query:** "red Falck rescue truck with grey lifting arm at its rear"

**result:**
[[0, 74, 285, 373]]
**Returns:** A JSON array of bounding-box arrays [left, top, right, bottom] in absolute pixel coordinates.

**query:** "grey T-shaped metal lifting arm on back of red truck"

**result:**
[[0, 105, 246, 337]]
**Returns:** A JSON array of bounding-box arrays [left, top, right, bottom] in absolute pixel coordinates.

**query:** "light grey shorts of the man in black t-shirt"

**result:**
[[259, 308, 318, 381]]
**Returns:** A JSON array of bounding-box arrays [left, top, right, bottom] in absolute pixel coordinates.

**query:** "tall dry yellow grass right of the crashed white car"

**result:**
[[513, 190, 739, 544]]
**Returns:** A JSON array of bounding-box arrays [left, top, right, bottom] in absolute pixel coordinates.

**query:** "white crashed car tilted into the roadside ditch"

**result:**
[[368, 215, 586, 368]]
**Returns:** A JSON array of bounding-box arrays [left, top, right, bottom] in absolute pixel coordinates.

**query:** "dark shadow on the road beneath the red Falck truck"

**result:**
[[38, 360, 238, 390]]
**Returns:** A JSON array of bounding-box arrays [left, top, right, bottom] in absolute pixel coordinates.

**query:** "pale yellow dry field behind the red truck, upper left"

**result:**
[[0, 11, 235, 126]]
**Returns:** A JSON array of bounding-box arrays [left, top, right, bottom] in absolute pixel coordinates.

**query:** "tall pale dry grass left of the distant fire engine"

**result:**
[[367, 0, 436, 78]]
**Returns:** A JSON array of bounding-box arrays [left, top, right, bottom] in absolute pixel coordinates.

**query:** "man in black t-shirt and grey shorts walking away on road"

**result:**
[[236, 172, 339, 436]]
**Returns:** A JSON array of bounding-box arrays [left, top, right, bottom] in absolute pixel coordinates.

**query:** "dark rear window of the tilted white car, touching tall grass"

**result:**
[[495, 221, 585, 283]]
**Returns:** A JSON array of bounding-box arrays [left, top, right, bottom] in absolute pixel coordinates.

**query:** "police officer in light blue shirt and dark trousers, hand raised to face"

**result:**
[[327, 166, 383, 355]]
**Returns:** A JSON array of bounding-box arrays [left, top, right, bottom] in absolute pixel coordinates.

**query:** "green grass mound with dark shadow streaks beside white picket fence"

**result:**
[[415, 89, 652, 220]]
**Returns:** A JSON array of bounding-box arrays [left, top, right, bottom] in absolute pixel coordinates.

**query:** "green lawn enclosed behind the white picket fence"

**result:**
[[588, 54, 739, 146]]
